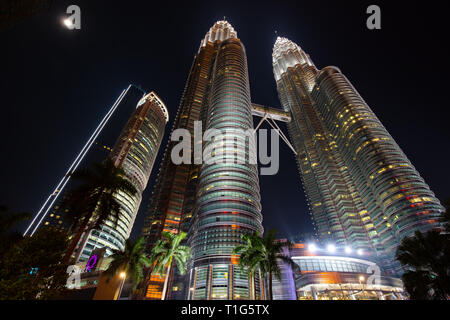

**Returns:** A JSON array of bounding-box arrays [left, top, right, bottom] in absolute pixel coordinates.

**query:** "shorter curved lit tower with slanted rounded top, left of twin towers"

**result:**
[[77, 92, 169, 261]]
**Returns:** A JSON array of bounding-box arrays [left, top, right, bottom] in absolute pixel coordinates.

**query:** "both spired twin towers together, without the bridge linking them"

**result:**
[[143, 21, 443, 299]]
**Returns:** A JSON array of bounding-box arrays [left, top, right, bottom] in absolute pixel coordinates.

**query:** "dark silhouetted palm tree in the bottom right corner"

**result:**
[[397, 230, 450, 300]]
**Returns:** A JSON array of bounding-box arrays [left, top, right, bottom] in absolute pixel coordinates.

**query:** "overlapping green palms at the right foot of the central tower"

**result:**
[[233, 230, 298, 300]]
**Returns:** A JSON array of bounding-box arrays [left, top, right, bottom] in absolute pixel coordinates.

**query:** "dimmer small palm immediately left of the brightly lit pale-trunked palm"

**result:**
[[105, 237, 151, 297]]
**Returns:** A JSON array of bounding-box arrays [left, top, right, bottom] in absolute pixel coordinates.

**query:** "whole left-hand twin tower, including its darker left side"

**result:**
[[143, 21, 262, 299]]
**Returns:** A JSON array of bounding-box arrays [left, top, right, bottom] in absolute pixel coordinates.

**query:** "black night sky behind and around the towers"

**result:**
[[0, 0, 450, 237]]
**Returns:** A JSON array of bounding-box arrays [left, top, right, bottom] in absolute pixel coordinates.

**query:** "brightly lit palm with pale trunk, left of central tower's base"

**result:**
[[150, 231, 191, 300]]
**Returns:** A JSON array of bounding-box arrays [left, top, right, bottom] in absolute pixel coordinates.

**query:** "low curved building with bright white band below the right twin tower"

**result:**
[[273, 243, 406, 300]]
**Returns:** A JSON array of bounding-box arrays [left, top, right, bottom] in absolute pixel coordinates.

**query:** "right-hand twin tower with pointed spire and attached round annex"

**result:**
[[273, 37, 443, 273]]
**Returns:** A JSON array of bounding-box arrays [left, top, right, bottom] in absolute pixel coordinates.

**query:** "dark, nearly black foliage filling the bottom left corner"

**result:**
[[0, 228, 68, 300]]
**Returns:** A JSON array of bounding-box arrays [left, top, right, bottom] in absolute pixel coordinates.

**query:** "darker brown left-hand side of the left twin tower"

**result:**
[[142, 21, 229, 299]]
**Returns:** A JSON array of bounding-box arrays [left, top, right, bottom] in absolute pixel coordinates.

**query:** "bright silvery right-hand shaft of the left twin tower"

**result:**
[[188, 22, 263, 300]]
